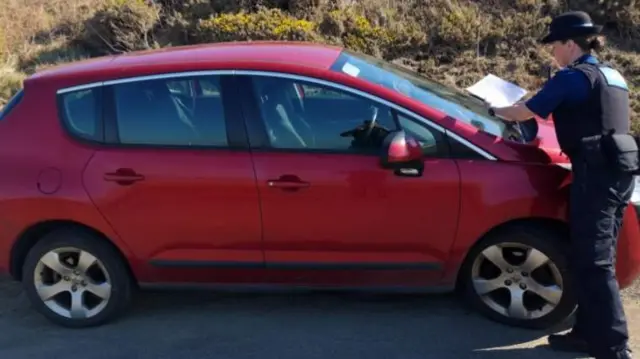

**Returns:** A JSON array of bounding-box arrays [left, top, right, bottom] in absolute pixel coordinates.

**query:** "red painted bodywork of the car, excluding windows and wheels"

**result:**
[[0, 42, 640, 328]]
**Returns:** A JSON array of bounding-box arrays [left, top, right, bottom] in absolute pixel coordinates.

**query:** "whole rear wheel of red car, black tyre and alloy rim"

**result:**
[[22, 228, 133, 328]]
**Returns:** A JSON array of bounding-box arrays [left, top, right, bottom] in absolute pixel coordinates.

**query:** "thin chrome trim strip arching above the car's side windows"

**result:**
[[57, 70, 497, 161]]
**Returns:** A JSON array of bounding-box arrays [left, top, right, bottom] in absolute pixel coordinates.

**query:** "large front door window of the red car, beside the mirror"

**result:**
[[253, 76, 397, 153]]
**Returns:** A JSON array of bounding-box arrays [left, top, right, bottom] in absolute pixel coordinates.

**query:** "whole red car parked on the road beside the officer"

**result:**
[[0, 42, 640, 328]]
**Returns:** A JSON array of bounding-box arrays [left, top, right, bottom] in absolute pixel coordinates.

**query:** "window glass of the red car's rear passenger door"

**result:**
[[113, 76, 227, 146]]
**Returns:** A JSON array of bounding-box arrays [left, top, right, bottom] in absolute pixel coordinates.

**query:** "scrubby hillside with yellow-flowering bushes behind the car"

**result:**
[[0, 0, 640, 130]]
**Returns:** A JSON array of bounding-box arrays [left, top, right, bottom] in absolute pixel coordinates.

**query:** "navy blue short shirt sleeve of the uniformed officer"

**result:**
[[525, 54, 598, 118]]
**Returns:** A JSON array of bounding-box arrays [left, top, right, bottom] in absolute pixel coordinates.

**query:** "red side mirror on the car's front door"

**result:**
[[380, 131, 424, 177]]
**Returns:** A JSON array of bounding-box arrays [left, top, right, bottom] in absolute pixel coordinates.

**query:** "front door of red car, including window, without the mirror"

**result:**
[[239, 74, 460, 284]]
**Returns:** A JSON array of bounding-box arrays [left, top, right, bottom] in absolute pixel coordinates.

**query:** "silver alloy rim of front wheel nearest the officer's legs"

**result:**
[[471, 243, 563, 320]]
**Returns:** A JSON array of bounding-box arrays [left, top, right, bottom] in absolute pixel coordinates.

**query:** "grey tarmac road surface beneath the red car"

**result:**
[[0, 279, 640, 359]]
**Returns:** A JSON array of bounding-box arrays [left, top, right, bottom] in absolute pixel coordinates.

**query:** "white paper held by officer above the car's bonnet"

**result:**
[[467, 74, 527, 107]]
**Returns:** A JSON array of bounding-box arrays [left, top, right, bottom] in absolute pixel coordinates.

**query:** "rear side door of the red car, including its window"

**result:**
[[74, 74, 264, 280]]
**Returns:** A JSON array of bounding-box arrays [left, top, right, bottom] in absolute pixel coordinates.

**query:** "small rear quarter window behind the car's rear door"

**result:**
[[59, 87, 102, 140]]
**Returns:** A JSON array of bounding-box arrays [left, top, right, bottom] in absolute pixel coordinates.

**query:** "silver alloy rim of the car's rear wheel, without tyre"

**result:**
[[34, 247, 112, 319]]
